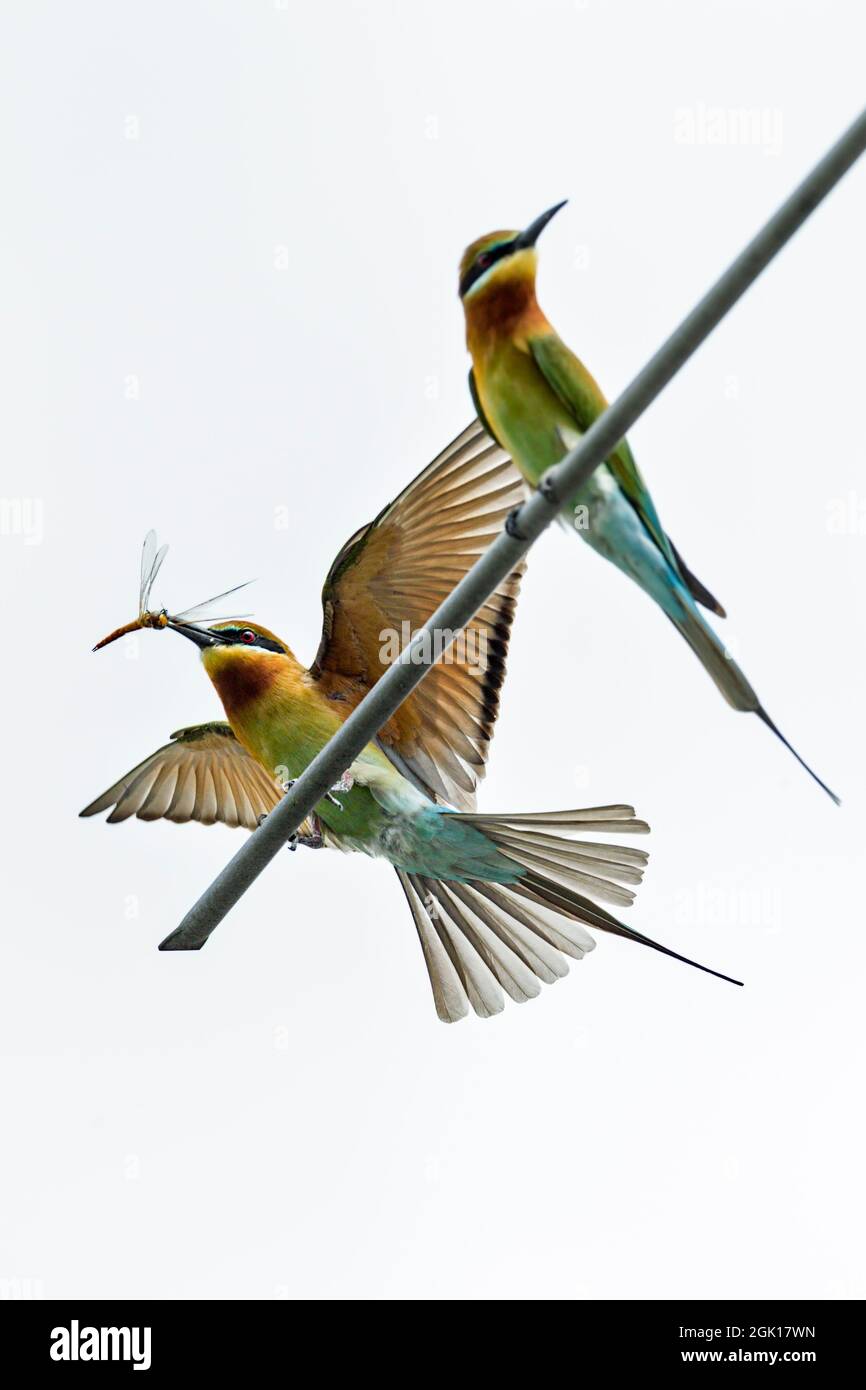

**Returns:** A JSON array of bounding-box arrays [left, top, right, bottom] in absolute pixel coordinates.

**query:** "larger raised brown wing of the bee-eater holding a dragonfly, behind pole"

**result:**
[[310, 421, 524, 809]]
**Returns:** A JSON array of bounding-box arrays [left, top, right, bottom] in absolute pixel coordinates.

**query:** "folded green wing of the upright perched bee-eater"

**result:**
[[528, 334, 680, 573]]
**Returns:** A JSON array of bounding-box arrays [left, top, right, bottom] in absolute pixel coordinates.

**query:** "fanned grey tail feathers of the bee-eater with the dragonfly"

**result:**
[[398, 806, 740, 1023]]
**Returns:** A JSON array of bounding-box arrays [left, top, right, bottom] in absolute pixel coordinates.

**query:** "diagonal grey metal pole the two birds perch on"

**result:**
[[160, 111, 866, 951]]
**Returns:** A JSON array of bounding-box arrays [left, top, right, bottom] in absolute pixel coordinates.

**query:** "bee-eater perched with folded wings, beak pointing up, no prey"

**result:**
[[459, 203, 838, 805]]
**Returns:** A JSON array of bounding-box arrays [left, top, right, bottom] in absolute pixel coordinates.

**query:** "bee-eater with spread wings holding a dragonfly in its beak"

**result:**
[[82, 425, 740, 1022]]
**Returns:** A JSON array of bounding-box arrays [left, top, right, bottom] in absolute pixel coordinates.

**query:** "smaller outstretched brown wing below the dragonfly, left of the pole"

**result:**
[[81, 723, 279, 830]]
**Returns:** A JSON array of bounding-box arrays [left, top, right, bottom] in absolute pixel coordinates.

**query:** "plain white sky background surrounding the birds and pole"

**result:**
[[0, 0, 866, 1298]]
